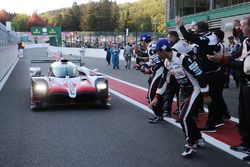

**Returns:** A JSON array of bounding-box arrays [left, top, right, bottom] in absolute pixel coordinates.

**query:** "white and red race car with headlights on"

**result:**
[[30, 59, 110, 110]]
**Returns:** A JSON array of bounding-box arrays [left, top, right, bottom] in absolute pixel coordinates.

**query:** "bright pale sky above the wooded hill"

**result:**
[[0, 0, 138, 15]]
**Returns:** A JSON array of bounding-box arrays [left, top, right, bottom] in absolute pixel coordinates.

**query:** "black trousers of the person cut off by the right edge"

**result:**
[[238, 83, 250, 149]]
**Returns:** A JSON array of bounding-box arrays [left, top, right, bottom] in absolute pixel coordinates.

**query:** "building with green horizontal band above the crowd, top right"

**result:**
[[167, 0, 250, 36]]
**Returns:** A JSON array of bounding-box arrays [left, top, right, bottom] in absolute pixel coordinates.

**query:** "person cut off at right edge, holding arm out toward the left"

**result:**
[[208, 16, 250, 161]]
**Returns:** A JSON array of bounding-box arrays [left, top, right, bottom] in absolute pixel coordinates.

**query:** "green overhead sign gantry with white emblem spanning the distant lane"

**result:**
[[31, 26, 62, 45]]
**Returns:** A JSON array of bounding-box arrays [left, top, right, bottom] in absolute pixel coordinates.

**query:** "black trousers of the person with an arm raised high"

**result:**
[[205, 71, 228, 127]]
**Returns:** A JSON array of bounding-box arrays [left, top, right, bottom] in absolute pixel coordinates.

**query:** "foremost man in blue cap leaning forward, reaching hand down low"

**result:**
[[149, 39, 211, 157]]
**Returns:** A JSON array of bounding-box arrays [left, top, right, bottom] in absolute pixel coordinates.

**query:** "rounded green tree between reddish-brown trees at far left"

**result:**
[[12, 14, 28, 32]]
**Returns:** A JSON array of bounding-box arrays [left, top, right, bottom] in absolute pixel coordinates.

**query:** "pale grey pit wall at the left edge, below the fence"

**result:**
[[0, 45, 18, 83]]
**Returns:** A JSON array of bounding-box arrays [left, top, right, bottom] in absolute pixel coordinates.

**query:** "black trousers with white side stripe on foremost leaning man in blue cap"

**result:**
[[179, 87, 202, 145]]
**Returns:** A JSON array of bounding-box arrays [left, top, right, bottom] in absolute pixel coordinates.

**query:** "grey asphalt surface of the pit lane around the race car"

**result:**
[[0, 49, 249, 167]]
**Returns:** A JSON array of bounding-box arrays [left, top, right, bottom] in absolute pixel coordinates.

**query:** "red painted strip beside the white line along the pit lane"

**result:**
[[108, 78, 240, 145]]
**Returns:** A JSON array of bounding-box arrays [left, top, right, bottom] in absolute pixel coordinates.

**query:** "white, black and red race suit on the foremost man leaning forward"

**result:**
[[156, 51, 209, 145]]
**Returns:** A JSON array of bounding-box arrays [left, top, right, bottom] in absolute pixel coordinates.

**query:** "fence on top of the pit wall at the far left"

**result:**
[[0, 23, 18, 48]]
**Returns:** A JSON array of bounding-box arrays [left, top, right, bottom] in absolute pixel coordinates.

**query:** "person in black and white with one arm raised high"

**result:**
[[176, 17, 224, 132]]
